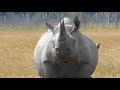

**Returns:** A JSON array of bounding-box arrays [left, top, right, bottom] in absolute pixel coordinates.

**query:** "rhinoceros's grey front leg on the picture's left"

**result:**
[[43, 60, 57, 78]]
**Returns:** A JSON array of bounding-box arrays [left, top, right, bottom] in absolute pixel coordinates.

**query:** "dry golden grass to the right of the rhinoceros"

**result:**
[[82, 28, 120, 78]]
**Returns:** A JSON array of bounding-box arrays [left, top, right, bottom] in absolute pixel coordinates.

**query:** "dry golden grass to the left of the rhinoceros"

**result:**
[[0, 28, 45, 78]]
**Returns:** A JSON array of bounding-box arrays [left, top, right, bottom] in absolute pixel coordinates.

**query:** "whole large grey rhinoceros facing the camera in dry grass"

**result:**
[[34, 16, 100, 78]]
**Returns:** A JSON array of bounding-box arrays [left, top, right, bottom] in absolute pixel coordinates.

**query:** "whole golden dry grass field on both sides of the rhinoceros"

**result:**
[[0, 28, 120, 78]]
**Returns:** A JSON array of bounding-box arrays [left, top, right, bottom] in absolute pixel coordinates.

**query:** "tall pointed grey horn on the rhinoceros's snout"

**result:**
[[59, 19, 66, 41]]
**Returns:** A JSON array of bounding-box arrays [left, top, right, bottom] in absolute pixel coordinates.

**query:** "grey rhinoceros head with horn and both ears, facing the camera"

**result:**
[[47, 17, 80, 61]]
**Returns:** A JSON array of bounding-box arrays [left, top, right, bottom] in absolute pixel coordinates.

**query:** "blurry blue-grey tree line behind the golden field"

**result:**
[[0, 12, 120, 27]]
